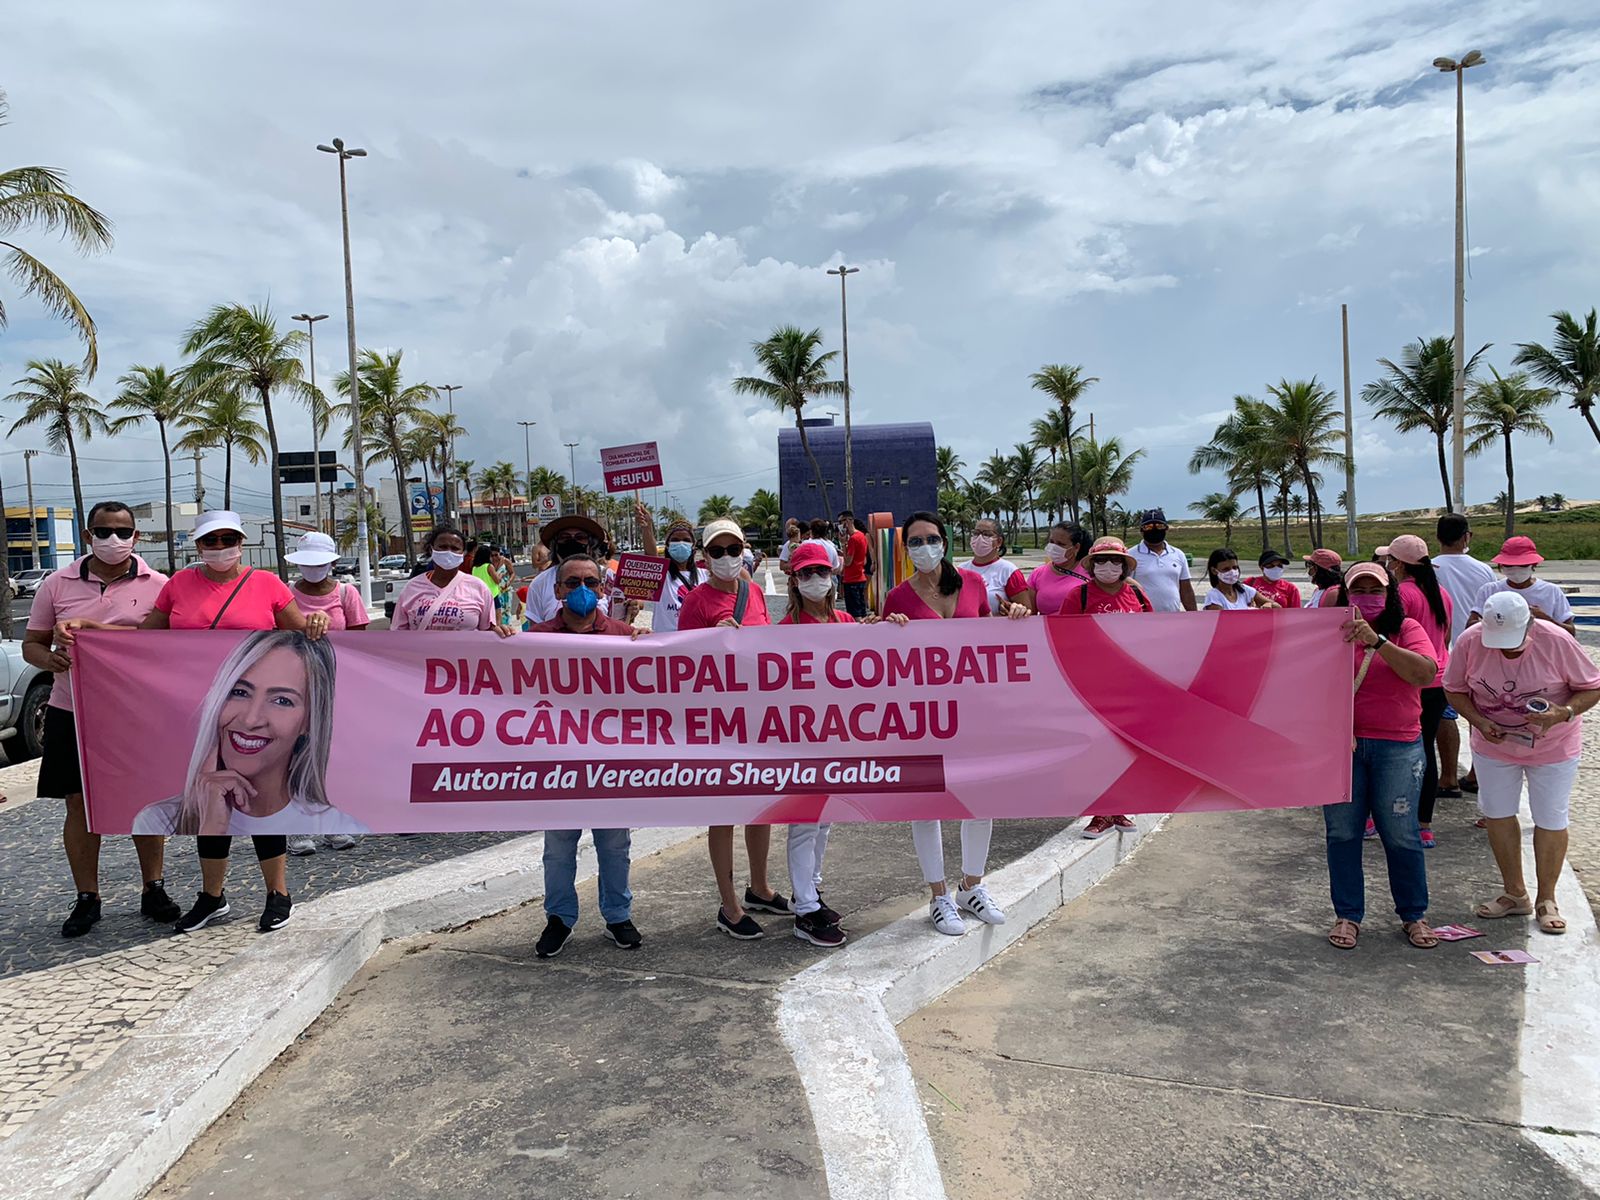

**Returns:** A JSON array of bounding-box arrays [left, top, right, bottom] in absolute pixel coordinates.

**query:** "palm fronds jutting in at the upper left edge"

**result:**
[[0, 91, 110, 374]]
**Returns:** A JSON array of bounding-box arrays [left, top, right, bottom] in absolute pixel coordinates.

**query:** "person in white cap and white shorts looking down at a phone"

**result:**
[[1445, 592, 1600, 933]]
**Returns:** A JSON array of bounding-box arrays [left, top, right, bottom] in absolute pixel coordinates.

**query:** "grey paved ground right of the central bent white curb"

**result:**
[[899, 806, 1589, 1200]]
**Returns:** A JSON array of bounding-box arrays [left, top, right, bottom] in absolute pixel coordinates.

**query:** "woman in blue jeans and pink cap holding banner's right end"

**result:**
[[1322, 563, 1438, 950]]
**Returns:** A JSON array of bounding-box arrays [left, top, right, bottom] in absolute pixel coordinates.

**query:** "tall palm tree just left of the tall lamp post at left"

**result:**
[[184, 304, 312, 578]]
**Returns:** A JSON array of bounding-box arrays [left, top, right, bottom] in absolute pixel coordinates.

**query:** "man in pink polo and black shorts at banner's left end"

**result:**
[[22, 501, 182, 938]]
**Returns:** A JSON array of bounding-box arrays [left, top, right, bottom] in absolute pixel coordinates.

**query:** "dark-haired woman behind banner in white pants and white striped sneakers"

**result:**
[[883, 512, 1029, 938]]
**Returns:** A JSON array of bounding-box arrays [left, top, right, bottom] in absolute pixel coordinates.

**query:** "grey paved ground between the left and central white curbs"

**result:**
[[150, 821, 1066, 1200]]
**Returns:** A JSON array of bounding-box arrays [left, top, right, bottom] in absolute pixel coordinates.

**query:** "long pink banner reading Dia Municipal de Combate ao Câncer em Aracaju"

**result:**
[[70, 610, 1350, 834]]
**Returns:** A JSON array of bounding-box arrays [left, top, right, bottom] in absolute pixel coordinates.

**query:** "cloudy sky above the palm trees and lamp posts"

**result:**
[[0, 0, 1600, 528]]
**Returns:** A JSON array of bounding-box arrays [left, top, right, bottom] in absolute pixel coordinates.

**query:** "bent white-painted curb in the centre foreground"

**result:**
[[778, 816, 1166, 1200]]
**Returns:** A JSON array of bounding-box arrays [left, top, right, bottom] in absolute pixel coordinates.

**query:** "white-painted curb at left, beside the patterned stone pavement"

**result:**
[[0, 829, 704, 1200]]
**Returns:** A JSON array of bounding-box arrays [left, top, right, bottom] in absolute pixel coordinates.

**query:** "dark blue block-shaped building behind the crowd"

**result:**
[[778, 416, 939, 523]]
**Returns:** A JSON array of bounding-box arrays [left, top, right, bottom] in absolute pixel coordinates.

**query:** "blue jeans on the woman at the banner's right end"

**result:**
[[1322, 738, 1427, 925]]
